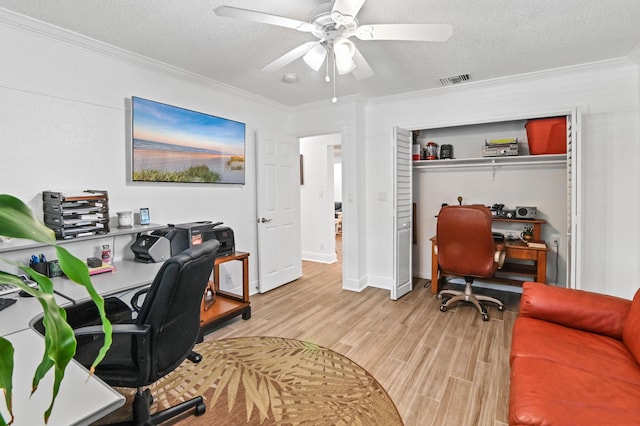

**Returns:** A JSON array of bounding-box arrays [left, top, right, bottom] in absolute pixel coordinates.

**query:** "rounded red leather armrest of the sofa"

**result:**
[[520, 282, 631, 340]]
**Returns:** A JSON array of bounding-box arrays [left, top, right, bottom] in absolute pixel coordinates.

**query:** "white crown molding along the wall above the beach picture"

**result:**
[[0, 8, 285, 110]]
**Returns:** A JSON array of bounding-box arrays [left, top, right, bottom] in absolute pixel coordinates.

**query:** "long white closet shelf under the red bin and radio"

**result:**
[[413, 154, 567, 169]]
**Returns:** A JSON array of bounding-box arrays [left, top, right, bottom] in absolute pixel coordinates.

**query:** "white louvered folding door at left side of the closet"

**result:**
[[391, 127, 413, 300]]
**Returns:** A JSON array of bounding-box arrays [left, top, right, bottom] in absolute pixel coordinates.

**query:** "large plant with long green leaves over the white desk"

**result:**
[[0, 194, 111, 425]]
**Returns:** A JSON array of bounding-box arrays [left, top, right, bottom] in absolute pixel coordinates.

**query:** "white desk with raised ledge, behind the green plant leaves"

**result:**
[[0, 225, 168, 426]]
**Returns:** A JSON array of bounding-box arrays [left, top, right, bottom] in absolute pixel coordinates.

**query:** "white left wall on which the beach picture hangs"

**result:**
[[0, 15, 286, 290]]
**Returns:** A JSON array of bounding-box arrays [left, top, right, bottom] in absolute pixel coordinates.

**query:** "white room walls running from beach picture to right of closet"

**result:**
[[5, 10, 640, 297]]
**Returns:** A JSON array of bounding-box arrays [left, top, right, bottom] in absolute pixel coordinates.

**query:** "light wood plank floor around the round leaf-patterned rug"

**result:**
[[205, 236, 519, 426]]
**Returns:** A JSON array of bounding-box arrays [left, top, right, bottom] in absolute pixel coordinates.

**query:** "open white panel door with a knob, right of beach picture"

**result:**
[[256, 132, 302, 293]]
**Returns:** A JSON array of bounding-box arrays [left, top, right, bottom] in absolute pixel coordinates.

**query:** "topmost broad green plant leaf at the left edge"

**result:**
[[0, 194, 56, 244]]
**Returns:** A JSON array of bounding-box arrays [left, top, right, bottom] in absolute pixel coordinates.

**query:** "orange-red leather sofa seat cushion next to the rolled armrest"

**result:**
[[510, 317, 640, 388]]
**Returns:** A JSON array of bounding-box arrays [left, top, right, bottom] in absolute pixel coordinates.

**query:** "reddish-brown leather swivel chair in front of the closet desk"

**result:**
[[435, 205, 505, 321]]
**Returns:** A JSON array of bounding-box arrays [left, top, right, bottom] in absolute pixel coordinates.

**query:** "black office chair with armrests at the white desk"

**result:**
[[72, 240, 219, 425]]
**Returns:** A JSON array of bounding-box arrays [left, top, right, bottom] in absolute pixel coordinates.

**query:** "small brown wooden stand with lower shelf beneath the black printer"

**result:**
[[200, 251, 251, 329]]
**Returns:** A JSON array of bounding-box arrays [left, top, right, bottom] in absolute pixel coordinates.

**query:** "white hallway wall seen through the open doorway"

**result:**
[[300, 134, 341, 263]]
